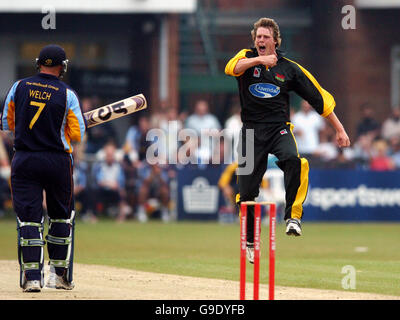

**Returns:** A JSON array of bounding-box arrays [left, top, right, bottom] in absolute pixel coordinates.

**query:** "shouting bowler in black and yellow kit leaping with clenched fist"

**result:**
[[225, 18, 350, 262]]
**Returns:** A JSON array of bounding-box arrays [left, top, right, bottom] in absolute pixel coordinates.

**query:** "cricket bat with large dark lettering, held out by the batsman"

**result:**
[[83, 94, 147, 128]]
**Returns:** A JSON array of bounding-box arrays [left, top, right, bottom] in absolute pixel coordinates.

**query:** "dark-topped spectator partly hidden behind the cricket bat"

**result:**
[[81, 97, 116, 154]]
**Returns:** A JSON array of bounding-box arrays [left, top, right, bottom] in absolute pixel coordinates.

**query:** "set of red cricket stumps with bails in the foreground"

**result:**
[[240, 201, 276, 300]]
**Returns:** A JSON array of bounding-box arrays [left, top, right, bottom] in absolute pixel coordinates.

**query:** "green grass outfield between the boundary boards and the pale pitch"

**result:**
[[0, 219, 400, 296]]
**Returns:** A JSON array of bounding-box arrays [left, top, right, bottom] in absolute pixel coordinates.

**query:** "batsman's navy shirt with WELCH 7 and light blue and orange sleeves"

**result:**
[[0, 73, 86, 153]]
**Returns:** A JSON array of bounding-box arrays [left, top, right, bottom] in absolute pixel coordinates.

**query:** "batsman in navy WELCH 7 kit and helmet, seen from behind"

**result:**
[[0, 45, 86, 292]]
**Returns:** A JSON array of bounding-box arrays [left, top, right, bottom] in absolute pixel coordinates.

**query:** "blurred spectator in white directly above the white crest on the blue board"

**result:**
[[185, 100, 221, 164]]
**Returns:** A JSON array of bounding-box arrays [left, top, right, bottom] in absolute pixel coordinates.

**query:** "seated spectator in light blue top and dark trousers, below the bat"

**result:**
[[92, 142, 131, 221]]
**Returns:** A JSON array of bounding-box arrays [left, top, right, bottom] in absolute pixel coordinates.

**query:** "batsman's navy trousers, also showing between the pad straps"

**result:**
[[11, 150, 74, 280]]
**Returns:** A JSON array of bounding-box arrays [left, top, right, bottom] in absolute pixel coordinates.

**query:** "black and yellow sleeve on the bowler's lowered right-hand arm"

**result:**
[[285, 58, 336, 117]]
